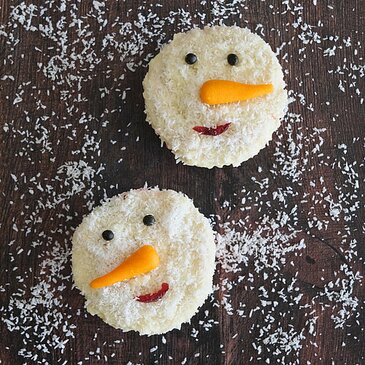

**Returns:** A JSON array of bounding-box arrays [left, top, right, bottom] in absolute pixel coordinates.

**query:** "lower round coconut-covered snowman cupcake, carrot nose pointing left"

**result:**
[[72, 188, 215, 335]]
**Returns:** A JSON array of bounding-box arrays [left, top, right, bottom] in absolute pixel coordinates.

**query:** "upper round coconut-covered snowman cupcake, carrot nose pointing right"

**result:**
[[143, 26, 288, 168]]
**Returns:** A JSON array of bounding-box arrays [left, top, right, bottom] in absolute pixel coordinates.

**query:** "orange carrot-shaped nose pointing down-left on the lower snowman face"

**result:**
[[90, 245, 160, 289]]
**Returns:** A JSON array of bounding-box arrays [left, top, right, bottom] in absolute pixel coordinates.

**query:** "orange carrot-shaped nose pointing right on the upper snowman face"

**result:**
[[200, 80, 274, 105]]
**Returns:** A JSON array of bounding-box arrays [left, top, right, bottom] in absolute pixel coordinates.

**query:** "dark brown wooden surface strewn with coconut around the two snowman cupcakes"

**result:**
[[0, 0, 365, 365]]
